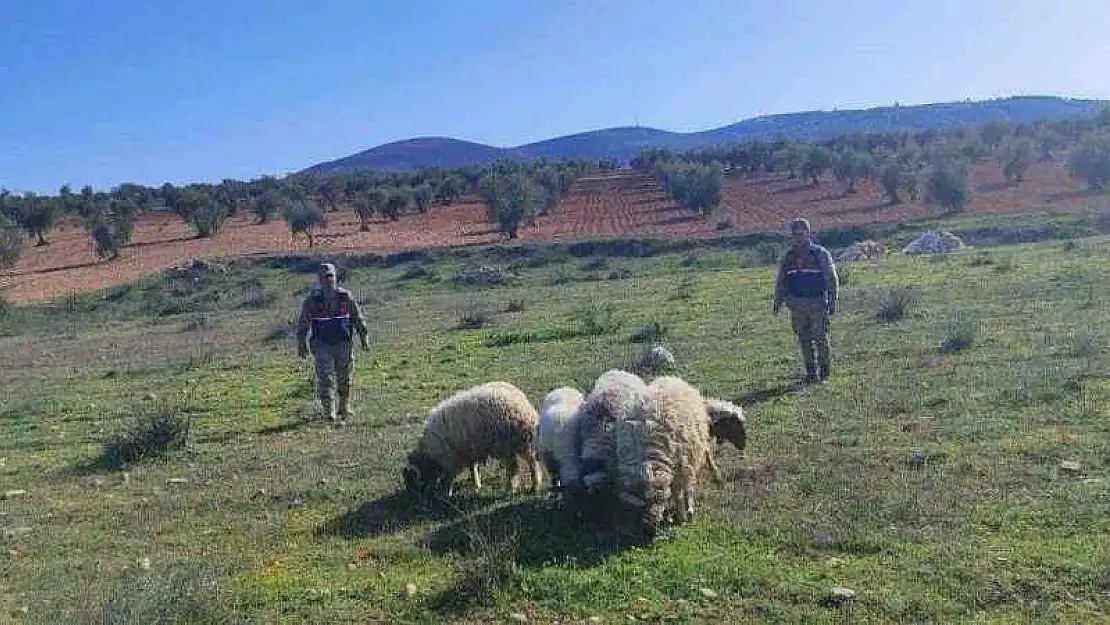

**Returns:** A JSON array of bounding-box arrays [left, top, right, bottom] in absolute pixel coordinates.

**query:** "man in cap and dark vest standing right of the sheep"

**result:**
[[771, 218, 840, 383]]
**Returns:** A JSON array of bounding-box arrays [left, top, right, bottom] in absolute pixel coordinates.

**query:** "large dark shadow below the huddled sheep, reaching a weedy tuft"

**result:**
[[424, 497, 647, 617]]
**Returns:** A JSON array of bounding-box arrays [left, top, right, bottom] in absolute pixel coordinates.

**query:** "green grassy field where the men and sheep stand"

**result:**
[[0, 215, 1110, 623]]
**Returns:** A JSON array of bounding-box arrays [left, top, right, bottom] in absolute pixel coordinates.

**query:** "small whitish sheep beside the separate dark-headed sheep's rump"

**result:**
[[536, 386, 585, 488]]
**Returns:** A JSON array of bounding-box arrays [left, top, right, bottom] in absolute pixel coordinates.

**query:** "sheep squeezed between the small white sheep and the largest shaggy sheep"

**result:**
[[578, 369, 647, 486]]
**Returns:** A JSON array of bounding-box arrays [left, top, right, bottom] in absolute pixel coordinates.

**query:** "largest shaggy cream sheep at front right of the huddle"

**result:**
[[614, 376, 715, 535]]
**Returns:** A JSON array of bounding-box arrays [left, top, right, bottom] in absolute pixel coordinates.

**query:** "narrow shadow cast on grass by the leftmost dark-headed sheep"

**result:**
[[315, 491, 495, 538]]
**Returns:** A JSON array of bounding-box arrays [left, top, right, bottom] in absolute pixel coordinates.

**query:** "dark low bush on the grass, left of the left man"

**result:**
[[102, 404, 192, 466]]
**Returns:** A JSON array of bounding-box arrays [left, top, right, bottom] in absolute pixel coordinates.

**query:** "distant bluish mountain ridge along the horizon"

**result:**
[[300, 95, 1104, 174]]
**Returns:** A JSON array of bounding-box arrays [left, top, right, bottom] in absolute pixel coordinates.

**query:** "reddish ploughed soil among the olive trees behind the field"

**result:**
[[0, 163, 1092, 301]]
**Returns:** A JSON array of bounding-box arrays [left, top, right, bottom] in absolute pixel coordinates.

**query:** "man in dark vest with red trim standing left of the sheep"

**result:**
[[296, 263, 370, 421]]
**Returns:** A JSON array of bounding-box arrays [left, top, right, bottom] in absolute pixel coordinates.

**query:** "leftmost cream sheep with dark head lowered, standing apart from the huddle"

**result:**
[[402, 381, 541, 497]]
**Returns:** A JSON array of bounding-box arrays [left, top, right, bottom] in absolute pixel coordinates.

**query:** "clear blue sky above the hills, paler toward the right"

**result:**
[[0, 0, 1110, 193]]
